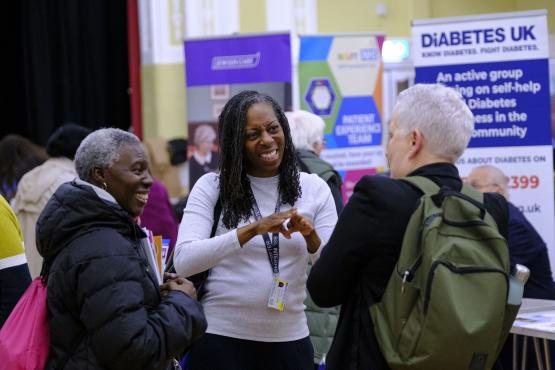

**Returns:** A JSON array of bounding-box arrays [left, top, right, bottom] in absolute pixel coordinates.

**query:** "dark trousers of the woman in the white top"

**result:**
[[187, 334, 314, 370]]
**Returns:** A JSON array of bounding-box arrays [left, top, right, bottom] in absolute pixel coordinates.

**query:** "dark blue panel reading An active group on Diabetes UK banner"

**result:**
[[416, 59, 551, 147]]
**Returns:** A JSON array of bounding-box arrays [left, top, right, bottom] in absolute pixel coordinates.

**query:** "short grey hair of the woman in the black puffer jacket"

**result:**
[[75, 128, 141, 182]]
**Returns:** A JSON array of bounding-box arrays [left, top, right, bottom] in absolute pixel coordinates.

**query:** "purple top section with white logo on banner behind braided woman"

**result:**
[[185, 34, 291, 87]]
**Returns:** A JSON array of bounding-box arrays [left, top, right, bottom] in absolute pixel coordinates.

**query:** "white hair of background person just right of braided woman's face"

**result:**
[[285, 110, 326, 150]]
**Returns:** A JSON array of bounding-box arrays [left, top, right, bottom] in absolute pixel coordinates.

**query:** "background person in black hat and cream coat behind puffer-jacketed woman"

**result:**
[[12, 123, 91, 278]]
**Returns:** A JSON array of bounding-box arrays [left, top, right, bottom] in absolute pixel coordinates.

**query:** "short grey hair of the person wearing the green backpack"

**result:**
[[393, 84, 474, 162]]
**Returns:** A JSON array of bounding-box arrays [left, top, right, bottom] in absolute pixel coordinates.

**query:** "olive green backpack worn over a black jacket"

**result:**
[[370, 177, 518, 370]]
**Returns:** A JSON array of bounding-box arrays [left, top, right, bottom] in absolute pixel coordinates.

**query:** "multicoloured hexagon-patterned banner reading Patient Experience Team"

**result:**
[[298, 34, 386, 200]]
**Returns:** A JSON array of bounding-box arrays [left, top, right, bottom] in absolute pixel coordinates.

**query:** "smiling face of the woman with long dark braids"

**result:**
[[243, 103, 285, 177]]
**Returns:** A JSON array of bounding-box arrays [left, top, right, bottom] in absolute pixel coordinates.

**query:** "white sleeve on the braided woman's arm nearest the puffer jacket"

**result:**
[[174, 173, 241, 276]]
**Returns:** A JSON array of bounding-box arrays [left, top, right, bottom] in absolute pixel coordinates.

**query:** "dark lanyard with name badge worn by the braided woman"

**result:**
[[250, 190, 289, 312]]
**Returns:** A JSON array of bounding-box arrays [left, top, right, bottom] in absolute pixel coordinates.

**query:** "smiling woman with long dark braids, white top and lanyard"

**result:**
[[174, 91, 337, 370]]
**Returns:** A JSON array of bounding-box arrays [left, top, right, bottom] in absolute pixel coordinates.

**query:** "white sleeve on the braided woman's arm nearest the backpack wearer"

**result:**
[[303, 175, 337, 263]]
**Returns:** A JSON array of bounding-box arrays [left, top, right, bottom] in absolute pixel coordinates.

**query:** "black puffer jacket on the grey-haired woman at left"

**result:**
[[37, 182, 206, 370]]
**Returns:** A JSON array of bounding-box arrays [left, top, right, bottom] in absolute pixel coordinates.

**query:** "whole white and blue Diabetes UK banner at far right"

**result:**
[[412, 10, 555, 270]]
